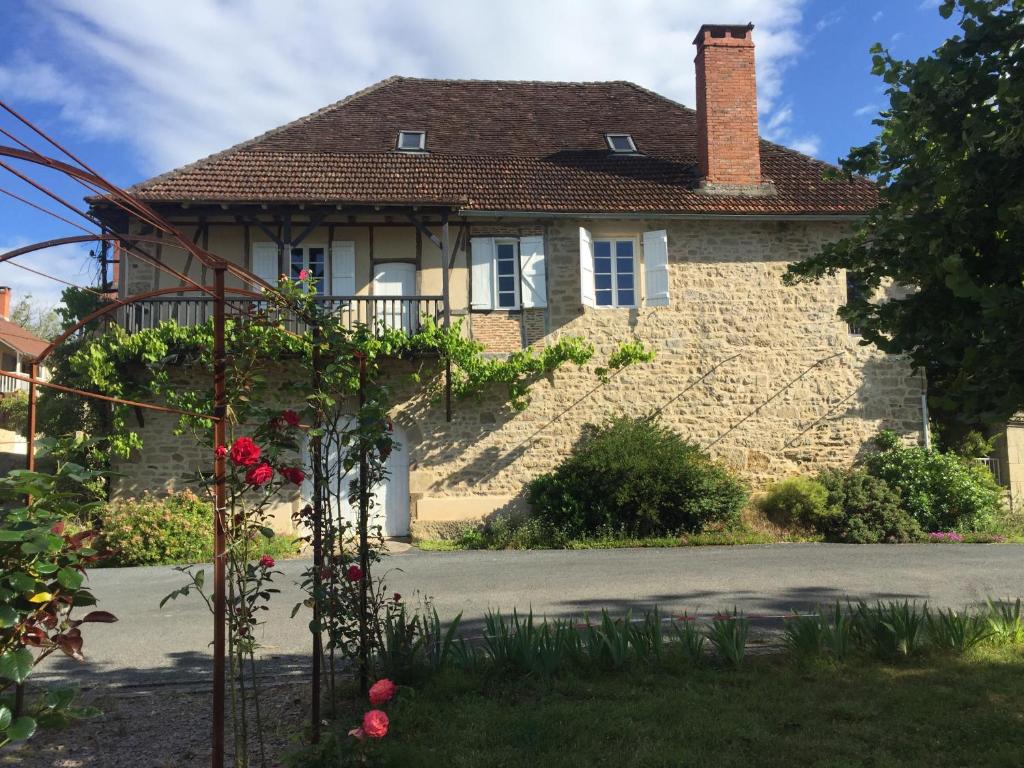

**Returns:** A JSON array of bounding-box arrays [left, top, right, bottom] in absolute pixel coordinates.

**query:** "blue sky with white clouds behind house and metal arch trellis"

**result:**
[[0, 0, 955, 308]]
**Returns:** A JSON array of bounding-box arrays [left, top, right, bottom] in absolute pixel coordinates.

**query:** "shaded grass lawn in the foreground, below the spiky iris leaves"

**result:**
[[331, 647, 1024, 768]]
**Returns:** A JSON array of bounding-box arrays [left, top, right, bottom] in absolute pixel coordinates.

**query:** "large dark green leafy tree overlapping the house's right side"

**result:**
[[785, 0, 1024, 431]]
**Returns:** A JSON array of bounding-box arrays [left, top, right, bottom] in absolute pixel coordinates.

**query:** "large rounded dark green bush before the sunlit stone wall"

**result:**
[[526, 417, 748, 537]]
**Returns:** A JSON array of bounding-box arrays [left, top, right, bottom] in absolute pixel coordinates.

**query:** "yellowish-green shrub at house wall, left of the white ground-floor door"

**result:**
[[101, 490, 213, 565]]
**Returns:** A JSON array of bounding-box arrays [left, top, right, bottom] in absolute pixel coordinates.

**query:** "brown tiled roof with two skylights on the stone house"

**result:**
[[125, 78, 877, 215]]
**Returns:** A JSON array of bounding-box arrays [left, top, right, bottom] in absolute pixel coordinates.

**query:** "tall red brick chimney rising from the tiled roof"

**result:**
[[693, 24, 774, 196]]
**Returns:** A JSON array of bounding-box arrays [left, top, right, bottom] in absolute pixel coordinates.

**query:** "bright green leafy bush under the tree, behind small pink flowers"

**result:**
[[863, 431, 1004, 532]]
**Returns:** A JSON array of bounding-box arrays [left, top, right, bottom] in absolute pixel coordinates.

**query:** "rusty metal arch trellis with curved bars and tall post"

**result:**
[[0, 100, 292, 768]]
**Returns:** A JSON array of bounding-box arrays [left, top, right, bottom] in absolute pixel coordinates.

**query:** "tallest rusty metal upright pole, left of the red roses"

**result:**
[[211, 265, 227, 768]]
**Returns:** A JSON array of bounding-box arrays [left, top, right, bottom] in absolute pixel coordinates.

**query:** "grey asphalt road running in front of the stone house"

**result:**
[[38, 544, 1024, 685]]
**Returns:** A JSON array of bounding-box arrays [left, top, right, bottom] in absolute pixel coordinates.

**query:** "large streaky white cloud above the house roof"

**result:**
[[6, 0, 806, 172]]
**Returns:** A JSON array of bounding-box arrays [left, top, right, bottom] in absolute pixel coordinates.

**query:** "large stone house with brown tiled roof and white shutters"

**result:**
[[93, 25, 924, 536]]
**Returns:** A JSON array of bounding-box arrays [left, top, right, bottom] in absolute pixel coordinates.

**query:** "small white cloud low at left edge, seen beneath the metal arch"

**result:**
[[0, 238, 96, 310]]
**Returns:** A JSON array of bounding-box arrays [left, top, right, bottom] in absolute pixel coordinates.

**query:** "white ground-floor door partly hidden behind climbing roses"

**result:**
[[302, 426, 409, 537]]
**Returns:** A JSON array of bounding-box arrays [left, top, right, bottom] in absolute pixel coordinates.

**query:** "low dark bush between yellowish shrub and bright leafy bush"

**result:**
[[818, 469, 923, 544]]
